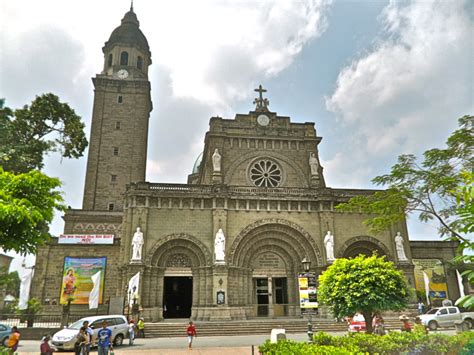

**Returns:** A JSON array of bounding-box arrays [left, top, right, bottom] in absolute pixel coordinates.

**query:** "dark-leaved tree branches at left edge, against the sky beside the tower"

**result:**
[[0, 93, 87, 173]]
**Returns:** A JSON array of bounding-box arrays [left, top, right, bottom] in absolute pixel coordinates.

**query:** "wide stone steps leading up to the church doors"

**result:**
[[145, 318, 401, 338]]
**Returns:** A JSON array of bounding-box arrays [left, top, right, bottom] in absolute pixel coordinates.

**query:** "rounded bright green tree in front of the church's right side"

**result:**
[[318, 255, 410, 333]]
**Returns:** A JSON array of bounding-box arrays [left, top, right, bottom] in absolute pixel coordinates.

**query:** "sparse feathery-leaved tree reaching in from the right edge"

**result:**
[[337, 116, 474, 242]]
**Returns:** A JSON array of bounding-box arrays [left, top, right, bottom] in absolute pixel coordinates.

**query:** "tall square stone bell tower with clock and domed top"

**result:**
[[82, 6, 153, 211]]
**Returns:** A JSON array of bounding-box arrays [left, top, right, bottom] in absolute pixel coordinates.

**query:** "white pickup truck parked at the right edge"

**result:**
[[420, 306, 474, 330]]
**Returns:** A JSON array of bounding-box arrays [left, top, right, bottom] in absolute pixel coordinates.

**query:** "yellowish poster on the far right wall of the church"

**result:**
[[412, 259, 448, 301]]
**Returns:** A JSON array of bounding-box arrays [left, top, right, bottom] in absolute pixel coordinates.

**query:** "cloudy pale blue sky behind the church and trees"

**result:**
[[0, 0, 474, 267]]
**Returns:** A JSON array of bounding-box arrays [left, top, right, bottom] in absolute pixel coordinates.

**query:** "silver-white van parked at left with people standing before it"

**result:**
[[53, 315, 128, 350]]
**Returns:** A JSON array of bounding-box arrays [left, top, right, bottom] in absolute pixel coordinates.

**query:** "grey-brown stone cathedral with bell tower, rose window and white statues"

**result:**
[[30, 8, 459, 321]]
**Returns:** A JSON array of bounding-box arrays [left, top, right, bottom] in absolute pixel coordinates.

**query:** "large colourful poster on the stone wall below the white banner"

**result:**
[[59, 256, 107, 304]]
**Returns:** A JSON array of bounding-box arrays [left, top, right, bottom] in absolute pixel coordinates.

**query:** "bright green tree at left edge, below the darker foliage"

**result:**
[[0, 168, 65, 253]]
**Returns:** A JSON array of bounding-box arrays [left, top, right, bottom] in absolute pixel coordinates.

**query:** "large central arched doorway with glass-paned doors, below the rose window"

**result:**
[[229, 220, 322, 318]]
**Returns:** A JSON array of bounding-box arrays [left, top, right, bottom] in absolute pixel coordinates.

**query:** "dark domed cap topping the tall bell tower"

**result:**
[[104, 9, 150, 53]]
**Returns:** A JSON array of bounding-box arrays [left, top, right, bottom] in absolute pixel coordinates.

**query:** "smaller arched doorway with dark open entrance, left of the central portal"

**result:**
[[144, 234, 211, 319]]
